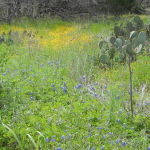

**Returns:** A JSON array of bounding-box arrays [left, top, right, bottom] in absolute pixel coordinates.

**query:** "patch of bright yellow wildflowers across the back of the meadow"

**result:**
[[0, 24, 92, 51]]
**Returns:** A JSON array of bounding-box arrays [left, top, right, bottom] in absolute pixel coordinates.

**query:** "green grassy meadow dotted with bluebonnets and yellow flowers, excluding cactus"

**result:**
[[0, 15, 150, 150]]
